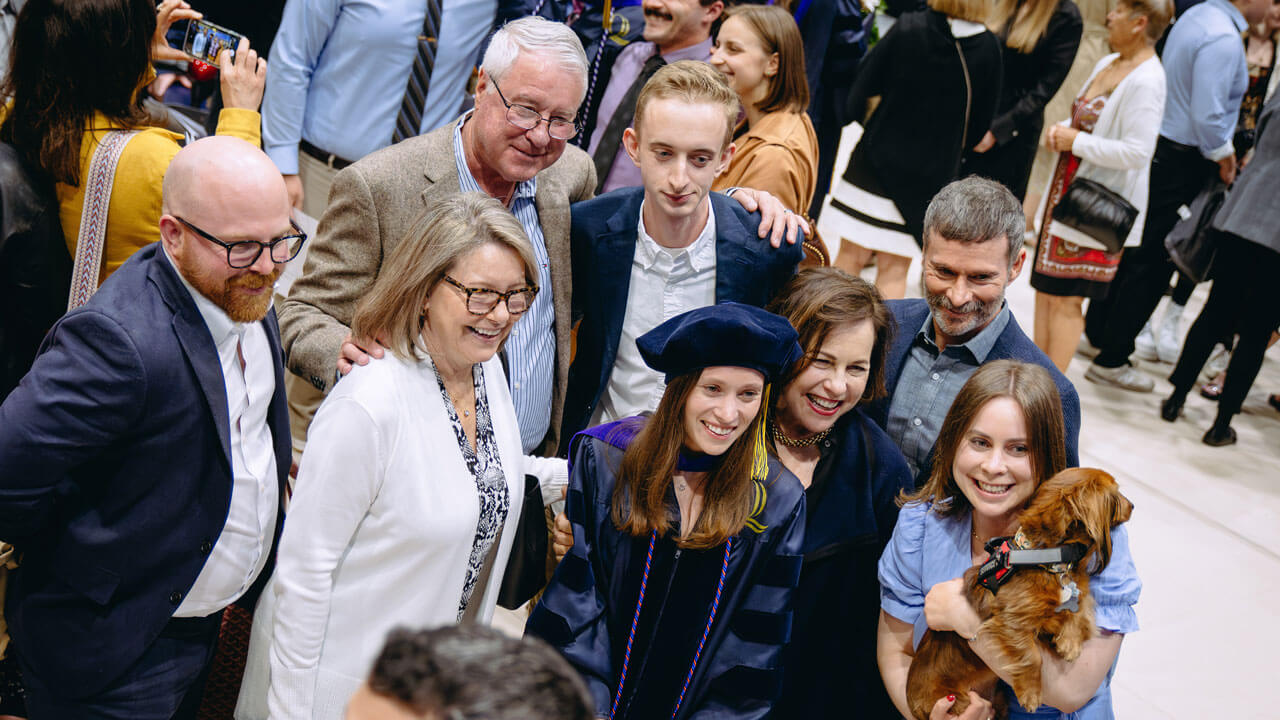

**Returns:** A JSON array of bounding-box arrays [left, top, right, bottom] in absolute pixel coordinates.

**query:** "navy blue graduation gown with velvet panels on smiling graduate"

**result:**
[[526, 425, 805, 720]]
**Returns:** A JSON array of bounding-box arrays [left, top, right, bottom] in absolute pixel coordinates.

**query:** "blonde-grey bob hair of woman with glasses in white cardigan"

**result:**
[[351, 192, 538, 360]]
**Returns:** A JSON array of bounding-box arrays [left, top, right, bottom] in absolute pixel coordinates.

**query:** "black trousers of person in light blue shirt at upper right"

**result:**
[[1085, 137, 1217, 368]]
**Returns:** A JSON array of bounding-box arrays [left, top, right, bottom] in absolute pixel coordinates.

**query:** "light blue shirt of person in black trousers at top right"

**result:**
[[1160, 0, 1249, 161]]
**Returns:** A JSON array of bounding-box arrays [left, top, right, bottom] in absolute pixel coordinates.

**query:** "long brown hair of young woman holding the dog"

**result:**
[[899, 360, 1066, 516]]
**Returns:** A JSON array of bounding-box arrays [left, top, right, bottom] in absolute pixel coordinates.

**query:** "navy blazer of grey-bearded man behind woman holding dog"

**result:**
[[867, 299, 1080, 487]]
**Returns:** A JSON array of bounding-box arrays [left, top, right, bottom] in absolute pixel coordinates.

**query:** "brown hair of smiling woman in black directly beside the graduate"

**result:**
[[765, 268, 895, 401]]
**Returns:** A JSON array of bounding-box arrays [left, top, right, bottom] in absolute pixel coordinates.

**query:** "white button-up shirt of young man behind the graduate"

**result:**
[[591, 202, 716, 425]]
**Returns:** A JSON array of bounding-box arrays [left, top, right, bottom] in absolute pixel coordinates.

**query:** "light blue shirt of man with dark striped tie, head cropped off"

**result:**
[[262, 0, 498, 174]]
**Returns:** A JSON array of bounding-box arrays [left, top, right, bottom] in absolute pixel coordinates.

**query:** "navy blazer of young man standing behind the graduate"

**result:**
[[559, 187, 804, 455]]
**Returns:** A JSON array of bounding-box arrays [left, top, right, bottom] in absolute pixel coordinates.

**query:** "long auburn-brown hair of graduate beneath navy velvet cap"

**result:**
[[613, 370, 768, 550]]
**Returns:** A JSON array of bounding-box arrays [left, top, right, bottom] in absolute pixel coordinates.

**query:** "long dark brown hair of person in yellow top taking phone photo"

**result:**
[[0, 0, 156, 186]]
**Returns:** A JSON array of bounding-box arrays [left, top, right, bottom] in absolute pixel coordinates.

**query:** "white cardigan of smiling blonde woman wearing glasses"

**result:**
[[252, 352, 525, 720]]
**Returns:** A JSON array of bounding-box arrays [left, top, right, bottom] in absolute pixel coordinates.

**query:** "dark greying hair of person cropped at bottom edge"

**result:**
[[369, 625, 595, 720]]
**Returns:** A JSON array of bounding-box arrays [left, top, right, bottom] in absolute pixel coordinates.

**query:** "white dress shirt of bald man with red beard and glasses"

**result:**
[[165, 252, 279, 618]]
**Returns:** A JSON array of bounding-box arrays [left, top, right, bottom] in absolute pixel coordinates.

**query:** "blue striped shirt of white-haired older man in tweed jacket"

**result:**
[[453, 113, 556, 452]]
